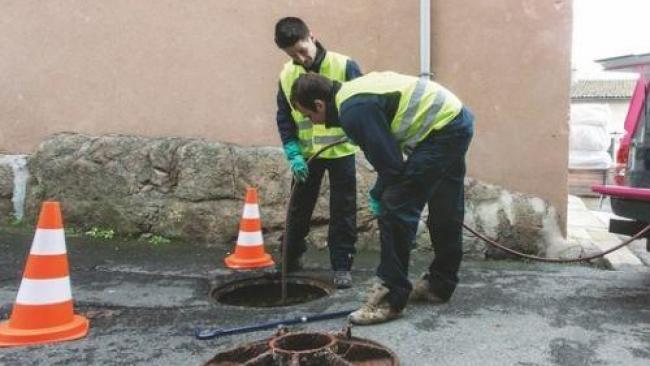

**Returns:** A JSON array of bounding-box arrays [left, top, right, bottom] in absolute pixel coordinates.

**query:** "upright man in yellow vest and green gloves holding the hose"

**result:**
[[275, 17, 361, 288]]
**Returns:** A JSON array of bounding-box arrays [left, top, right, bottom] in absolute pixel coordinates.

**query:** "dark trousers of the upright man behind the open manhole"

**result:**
[[287, 154, 357, 271]]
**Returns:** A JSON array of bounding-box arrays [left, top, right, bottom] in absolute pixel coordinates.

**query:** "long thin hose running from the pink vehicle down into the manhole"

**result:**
[[306, 139, 650, 264]]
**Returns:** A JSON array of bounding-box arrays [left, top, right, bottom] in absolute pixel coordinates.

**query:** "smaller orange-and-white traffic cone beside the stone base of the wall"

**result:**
[[224, 188, 274, 269]]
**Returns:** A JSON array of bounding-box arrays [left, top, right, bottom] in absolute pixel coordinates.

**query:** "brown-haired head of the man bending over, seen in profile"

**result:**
[[291, 72, 334, 124]]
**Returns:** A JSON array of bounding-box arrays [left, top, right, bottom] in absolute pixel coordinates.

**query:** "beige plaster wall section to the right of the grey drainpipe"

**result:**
[[431, 0, 572, 229]]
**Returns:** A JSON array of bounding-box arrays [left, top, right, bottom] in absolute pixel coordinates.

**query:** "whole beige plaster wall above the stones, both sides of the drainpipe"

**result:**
[[0, 0, 571, 229]]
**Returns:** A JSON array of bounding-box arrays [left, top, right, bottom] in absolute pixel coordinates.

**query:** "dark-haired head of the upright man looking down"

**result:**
[[275, 17, 318, 68]]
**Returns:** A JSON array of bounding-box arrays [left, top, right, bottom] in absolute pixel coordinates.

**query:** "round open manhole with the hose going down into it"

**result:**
[[210, 276, 334, 308]]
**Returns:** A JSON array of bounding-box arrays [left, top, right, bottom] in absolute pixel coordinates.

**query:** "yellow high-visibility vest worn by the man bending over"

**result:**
[[335, 72, 463, 154]]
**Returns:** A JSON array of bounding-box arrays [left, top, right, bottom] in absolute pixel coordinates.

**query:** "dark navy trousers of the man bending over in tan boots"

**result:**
[[377, 108, 474, 310]]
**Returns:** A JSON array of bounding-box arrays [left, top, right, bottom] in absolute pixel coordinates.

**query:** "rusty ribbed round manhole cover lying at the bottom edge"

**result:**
[[204, 328, 399, 366]]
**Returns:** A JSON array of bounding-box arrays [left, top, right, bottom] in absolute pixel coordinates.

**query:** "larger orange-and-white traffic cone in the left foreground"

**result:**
[[0, 202, 88, 347]]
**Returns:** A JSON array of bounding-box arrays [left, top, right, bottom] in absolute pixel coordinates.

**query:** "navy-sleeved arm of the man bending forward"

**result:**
[[340, 96, 404, 190]]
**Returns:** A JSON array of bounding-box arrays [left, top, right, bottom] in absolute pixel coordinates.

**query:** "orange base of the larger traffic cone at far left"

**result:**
[[0, 315, 89, 347]]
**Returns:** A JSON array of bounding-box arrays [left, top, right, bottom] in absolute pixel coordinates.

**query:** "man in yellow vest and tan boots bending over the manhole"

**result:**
[[291, 72, 474, 324]]
